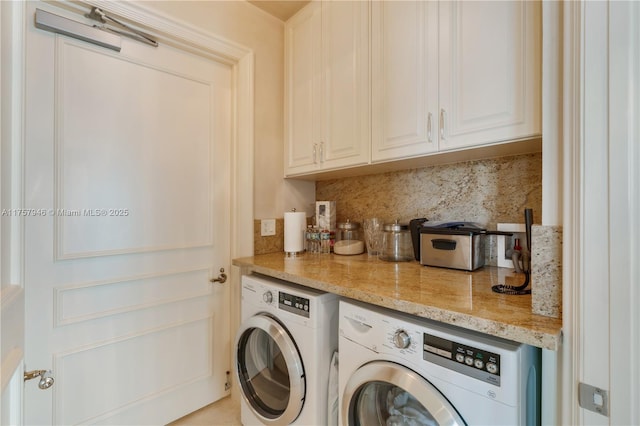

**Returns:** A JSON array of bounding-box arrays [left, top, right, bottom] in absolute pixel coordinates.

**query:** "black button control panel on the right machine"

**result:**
[[422, 333, 500, 385]]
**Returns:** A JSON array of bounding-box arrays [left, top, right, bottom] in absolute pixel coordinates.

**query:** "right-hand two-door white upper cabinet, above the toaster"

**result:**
[[371, 0, 542, 162]]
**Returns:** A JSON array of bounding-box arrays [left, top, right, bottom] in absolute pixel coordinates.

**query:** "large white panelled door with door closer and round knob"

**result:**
[[24, 3, 232, 424]]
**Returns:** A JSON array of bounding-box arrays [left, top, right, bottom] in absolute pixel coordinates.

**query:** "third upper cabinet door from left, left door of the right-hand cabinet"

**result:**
[[371, 0, 438, 162]]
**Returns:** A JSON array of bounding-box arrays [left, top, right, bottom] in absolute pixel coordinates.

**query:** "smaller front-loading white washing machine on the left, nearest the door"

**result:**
[[235, 275, 338, 426]]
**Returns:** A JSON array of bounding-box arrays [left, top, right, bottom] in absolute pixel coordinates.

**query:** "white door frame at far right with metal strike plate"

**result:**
[[558, 1, 640, 425]]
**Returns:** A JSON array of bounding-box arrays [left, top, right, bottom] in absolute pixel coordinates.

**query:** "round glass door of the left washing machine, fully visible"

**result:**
[[235, 314, 306, 424]]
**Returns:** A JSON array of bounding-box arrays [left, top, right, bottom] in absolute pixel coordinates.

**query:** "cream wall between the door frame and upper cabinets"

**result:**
[[143, 0, 315, 219]]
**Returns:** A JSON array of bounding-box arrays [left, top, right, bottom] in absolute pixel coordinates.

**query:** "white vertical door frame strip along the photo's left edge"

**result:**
[[0, 2, 25, 424]]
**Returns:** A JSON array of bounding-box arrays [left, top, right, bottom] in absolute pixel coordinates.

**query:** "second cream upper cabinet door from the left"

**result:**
[[320, 0, 371, 169]]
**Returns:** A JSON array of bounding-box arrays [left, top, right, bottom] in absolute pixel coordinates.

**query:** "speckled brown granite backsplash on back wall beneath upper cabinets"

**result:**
[[316, 153, 542, 229]]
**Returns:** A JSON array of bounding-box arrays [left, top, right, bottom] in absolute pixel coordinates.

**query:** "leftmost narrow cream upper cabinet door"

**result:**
[[285, 2, 322, 175]]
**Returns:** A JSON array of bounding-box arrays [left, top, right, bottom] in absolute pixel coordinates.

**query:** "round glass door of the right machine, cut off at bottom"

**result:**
[[342, 361, 466, 426]]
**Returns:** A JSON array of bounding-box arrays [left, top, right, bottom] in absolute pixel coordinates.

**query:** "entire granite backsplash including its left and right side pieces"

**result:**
[[254, 153, 562, 318]]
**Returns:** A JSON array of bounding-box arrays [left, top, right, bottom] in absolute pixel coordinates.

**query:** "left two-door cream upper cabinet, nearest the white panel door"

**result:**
[[285, 0, 371, 176]]
